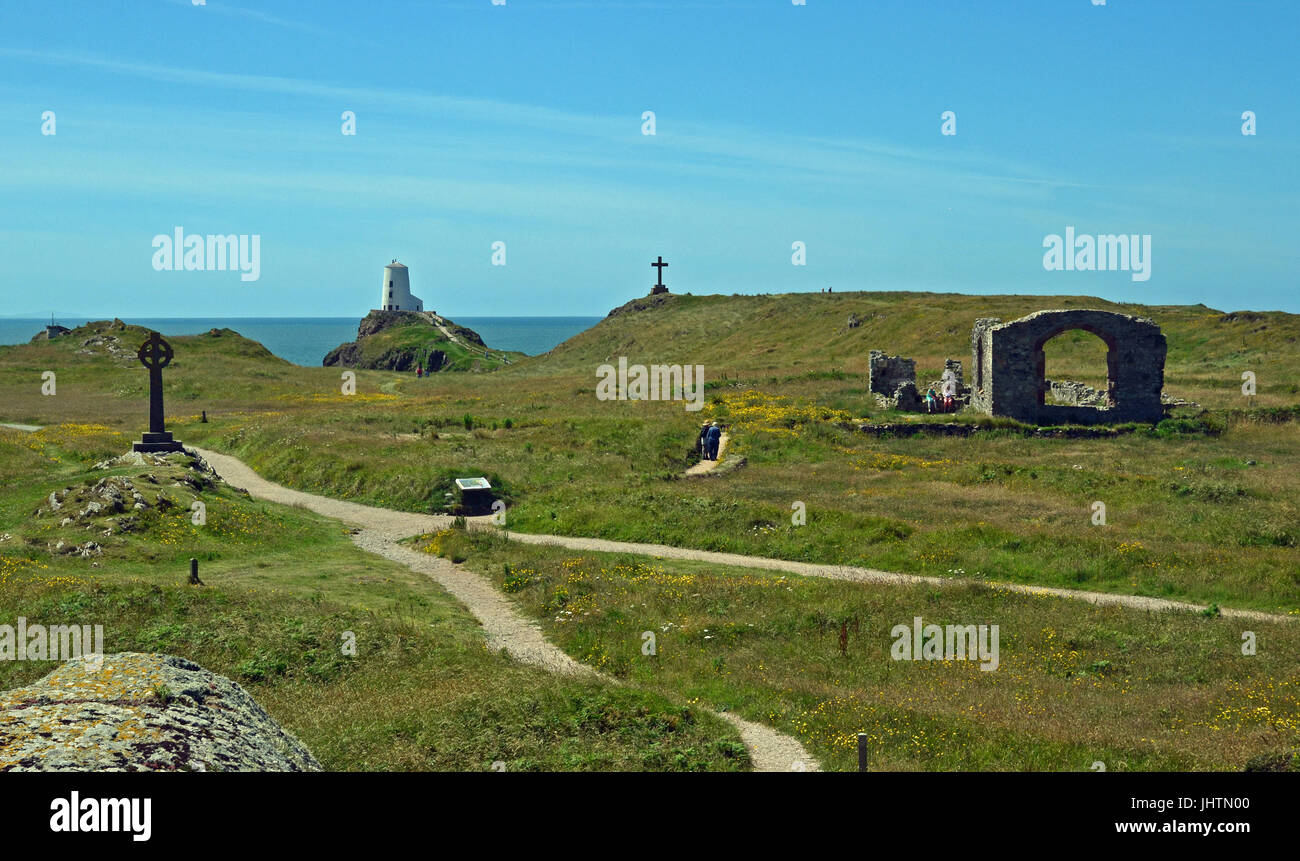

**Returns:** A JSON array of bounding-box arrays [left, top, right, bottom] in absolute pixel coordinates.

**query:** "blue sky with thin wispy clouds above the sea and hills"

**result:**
[[0, 0, 1300, 317]]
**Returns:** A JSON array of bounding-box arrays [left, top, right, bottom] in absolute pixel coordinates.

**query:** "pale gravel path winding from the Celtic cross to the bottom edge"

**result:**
[[195, 449, 819, 771]]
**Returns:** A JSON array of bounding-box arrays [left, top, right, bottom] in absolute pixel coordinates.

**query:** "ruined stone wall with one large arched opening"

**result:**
[[971, 310, 1166, 424]]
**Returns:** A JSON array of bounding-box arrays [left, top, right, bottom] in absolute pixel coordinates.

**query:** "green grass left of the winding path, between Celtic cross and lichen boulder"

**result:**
[[0, 428, 749, 771]]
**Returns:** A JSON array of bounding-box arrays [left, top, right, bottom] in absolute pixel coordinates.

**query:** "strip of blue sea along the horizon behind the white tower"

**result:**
[[0, 317, 602, 367]]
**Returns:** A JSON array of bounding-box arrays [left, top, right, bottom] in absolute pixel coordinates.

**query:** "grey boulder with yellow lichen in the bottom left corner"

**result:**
[[0, 652, 321, 771]]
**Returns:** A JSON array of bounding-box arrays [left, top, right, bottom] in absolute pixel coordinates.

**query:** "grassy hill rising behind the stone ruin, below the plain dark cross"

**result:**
[[528, 293, 1300, 407]]
